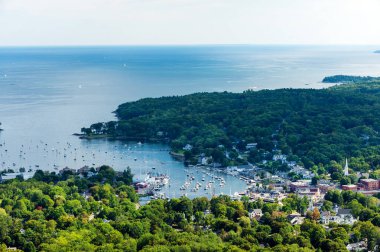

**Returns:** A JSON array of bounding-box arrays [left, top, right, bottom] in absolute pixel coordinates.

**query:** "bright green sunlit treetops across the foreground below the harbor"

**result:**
[[0, 168, 380, 251]]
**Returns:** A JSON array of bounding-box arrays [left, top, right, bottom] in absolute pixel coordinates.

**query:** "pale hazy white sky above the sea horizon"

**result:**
[[0, 0, 380, 45]]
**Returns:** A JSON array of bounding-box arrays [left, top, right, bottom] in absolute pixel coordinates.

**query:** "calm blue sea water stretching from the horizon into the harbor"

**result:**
[[0, 46, 380, 195]]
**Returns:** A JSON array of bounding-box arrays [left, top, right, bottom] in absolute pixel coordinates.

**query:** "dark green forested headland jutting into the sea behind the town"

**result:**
[[82, 82, 380, 171]]
